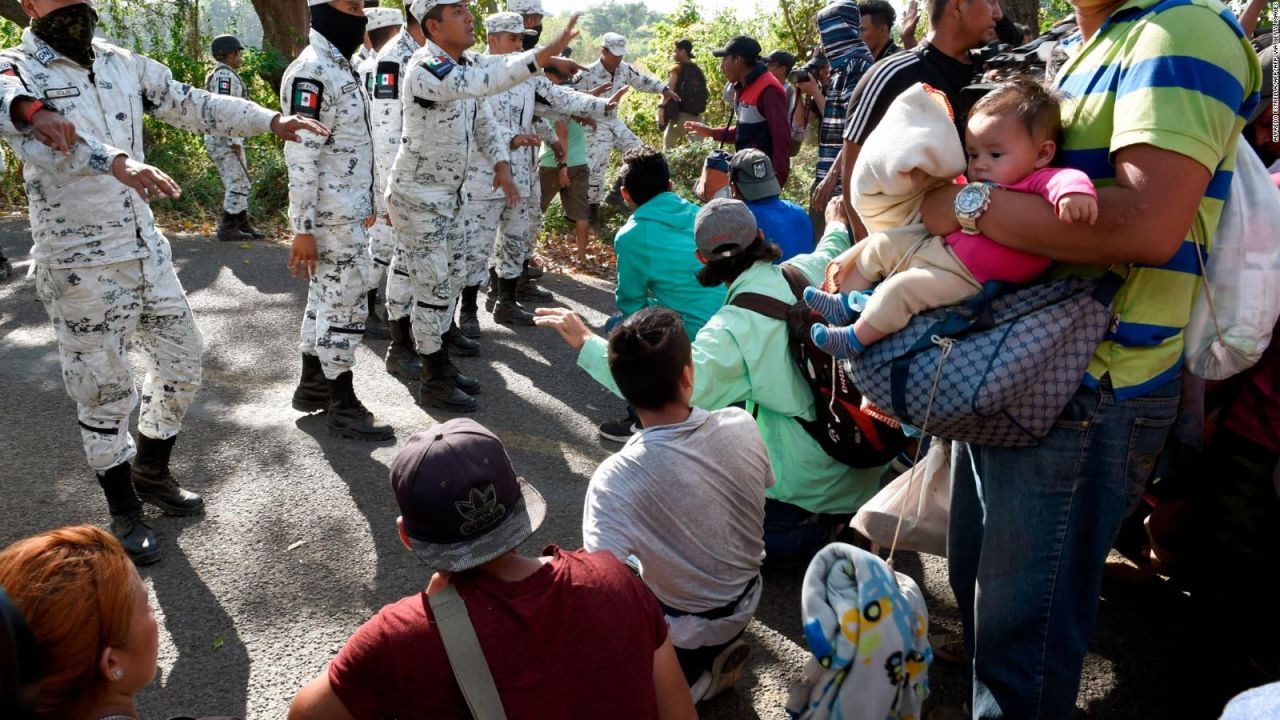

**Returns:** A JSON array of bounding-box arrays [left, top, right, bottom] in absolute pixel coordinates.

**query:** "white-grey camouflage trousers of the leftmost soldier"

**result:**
[[36, 245, 204, 470]]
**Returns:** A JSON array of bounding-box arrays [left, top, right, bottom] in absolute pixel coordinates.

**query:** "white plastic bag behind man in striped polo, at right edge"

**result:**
[[1184, 140, 1280, 380]]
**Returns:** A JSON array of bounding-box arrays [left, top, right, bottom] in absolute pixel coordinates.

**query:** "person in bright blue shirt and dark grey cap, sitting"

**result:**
[[728, 147, 813, 264]]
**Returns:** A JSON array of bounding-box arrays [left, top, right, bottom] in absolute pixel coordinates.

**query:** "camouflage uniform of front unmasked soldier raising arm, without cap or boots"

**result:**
[[387, 40, 539, 355]]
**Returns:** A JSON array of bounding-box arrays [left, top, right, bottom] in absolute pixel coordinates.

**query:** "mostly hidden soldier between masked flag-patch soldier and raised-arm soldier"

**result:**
[[371, 9, 426, 379]]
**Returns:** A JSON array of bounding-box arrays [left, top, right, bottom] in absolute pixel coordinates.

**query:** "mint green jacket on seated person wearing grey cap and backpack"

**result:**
[[577, 225, 884, 514]]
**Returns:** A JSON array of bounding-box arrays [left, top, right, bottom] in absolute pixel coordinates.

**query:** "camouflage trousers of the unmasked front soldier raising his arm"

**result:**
[[388, 193, 471, 355]]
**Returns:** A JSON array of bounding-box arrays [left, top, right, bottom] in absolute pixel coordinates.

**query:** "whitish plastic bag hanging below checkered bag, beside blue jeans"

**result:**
[[852, 438, 951, 557]]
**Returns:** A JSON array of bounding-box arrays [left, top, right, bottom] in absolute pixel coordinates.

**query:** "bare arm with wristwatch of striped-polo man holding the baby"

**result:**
[[923, 145, 1211, 265]]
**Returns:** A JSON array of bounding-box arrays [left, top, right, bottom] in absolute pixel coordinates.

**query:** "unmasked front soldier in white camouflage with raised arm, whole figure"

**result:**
[[387, 0, 576, 411]]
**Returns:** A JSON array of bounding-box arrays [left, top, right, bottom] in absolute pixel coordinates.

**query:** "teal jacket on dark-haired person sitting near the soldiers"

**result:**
[[613, 192, 724, 340]]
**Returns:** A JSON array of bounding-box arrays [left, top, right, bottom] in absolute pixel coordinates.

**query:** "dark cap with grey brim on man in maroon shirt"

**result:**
[[390, 418, 547, 573]]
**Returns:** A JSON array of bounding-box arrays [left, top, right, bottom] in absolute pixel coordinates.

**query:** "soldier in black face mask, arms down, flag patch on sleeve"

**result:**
[[280, 0, 394, 441]]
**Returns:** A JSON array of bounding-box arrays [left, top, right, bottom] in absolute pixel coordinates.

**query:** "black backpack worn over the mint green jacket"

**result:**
[[730, 265, 906, 468]]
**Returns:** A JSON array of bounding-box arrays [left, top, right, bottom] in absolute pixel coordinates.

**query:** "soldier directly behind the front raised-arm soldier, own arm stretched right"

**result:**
[[460, 13, 617, 336]]
